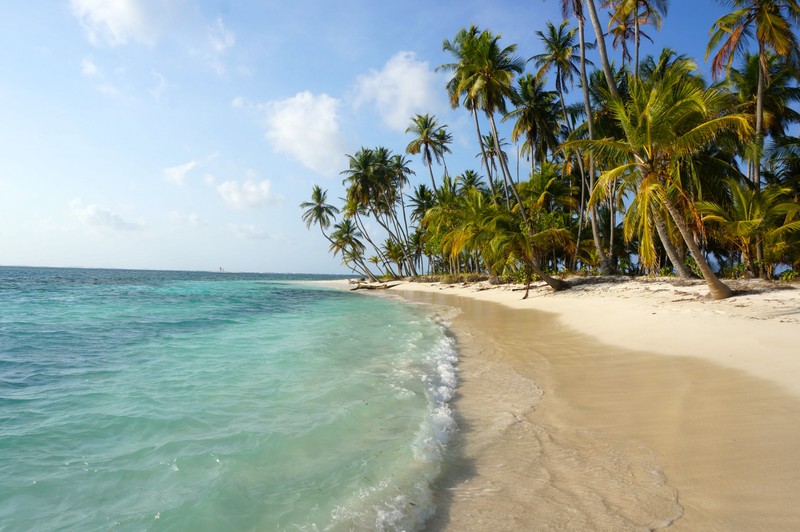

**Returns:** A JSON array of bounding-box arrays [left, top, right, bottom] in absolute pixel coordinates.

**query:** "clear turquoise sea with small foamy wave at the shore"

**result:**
[[0, 267, 458, 532]]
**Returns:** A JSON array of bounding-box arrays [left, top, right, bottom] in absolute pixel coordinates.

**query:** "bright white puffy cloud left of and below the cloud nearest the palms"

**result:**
[[266, 91, 345, 175]]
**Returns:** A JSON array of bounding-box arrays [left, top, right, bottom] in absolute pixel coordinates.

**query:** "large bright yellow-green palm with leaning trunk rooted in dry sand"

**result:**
[[567, 61, 752, 299]]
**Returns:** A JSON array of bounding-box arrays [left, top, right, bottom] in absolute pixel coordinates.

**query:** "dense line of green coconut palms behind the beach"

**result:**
[[301, 0, 800, 299]]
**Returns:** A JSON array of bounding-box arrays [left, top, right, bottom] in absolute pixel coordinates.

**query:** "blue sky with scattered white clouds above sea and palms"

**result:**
[[0, 0, 736, 273]]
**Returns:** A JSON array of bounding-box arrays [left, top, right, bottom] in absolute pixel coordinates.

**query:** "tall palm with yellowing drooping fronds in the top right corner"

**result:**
[[706, 0, 800, 186]]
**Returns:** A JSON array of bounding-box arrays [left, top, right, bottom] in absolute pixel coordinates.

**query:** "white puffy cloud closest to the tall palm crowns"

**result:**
[[354, 52, 445, 131]]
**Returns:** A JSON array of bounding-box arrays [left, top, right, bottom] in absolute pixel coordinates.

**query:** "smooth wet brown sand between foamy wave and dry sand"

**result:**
[[392, 287, 800, 531]]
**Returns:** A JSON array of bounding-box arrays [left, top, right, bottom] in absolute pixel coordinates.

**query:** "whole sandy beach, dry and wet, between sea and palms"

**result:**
[[372, 278, 800, 531]]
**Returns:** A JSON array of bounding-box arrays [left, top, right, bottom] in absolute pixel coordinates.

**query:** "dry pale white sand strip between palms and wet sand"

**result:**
[[392, 278, 800, 397]]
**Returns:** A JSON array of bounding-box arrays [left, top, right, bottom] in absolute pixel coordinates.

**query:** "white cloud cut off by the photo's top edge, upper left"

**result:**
[[70, 0, 166, 46]]
